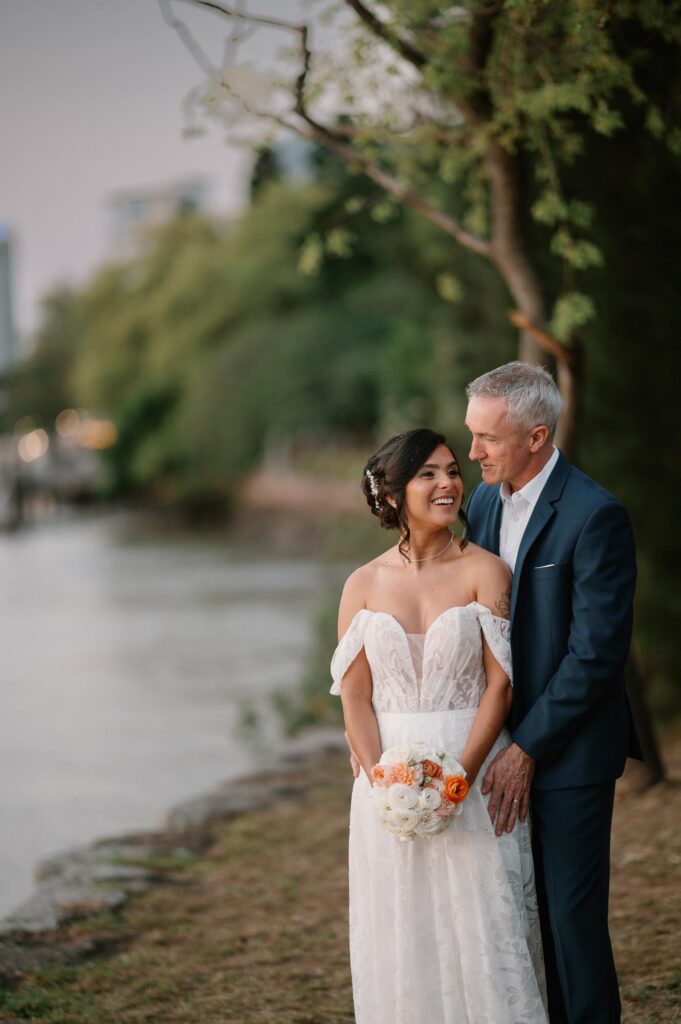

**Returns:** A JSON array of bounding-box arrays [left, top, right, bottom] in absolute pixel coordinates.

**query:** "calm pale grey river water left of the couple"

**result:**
[[0, 517, 323, 916]]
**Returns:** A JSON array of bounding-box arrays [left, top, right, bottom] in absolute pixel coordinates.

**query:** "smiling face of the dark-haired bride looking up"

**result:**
[[405, 444, 464, 529]]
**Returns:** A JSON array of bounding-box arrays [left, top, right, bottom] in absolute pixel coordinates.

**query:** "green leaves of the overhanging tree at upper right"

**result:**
[[284, 0, 681, 360]]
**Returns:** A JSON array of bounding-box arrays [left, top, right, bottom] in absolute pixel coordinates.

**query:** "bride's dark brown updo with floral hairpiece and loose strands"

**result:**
[[361, 427, 470, 561]]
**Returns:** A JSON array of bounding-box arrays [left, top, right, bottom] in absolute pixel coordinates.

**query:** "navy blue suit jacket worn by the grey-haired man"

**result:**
[[466, 455, 640, 790]]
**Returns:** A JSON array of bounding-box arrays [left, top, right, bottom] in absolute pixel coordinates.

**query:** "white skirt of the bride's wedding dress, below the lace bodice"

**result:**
[[349, 708, 548, 1024]]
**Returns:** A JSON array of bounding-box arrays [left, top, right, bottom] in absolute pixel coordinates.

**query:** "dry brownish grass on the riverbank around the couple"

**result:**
[[0, 741, 681, 1024]]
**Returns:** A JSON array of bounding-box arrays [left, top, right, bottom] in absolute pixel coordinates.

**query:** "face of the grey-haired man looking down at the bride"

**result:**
[[466, 397, 533, 490]]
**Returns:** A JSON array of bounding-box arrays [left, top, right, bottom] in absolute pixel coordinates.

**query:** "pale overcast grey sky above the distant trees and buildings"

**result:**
[[0, 0, 311, 332]]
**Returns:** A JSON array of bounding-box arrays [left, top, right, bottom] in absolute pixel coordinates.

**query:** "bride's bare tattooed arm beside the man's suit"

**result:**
[[460, 559, 512, 782]]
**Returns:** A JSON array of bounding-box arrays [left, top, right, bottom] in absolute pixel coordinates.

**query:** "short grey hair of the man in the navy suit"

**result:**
[[466, 362, 563, 440]]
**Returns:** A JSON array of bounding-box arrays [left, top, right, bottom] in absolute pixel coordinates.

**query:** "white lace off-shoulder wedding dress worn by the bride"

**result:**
[[331, 603, 548, 1024]]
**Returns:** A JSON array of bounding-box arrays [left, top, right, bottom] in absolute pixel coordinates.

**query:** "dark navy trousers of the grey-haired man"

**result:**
[[531, 782, 621, 1024]]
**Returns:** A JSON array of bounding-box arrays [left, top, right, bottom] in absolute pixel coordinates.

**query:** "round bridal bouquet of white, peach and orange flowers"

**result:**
[[372, 742, 468, 841]]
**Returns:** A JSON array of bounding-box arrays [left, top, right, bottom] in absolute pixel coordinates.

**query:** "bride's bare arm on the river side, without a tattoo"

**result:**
[[338, 570, 381, 780]]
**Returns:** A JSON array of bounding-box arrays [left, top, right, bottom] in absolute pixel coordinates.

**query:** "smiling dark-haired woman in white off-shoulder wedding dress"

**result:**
[[331, 429, 548, 1024]]
